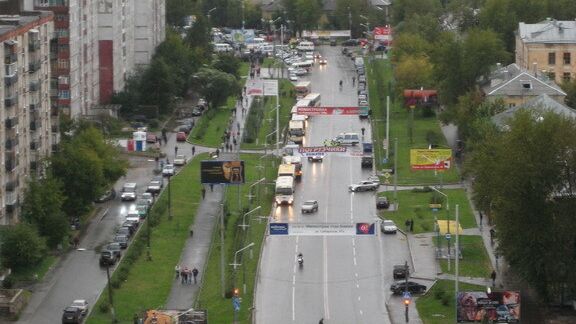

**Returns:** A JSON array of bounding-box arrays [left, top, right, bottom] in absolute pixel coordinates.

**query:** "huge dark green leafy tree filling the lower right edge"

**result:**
[[469, 110, 576, 301]]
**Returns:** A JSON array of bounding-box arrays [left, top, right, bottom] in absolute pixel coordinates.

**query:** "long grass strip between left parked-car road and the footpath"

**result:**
[[87, 154, 208, 324]]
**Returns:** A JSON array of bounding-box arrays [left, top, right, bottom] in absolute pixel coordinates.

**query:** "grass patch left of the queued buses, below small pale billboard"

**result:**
[[241, 79, 296, 149]]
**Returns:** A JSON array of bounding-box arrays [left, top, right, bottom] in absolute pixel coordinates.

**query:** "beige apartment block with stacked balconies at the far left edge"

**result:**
[[0, 5, 58, 225]]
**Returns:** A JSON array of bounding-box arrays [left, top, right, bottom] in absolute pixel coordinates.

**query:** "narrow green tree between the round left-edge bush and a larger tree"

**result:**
[[22, 174, 70, 248]]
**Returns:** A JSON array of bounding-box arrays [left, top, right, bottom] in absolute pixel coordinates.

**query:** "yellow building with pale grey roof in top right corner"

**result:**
[[516, 19, 576, 84]]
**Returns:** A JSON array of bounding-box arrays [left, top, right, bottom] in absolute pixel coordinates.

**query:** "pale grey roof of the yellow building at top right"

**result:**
[[518, 19, 576, 44]]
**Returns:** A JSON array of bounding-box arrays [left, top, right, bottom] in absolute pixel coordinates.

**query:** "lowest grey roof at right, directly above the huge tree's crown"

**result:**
[[492, 94, 576, 127]]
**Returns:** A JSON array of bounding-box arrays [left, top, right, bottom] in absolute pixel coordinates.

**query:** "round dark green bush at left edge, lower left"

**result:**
[[0, 223, 46, 270]]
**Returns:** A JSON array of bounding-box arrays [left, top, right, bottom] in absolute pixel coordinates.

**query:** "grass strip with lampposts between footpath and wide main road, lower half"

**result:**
[[197, 154, 277, 323]]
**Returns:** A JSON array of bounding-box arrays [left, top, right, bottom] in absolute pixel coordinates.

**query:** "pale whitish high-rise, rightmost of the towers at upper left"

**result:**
[[134, 0, 166, 66]]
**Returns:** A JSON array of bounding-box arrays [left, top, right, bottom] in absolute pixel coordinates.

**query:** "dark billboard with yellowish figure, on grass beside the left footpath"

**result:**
[[200, 160, 245, 184]]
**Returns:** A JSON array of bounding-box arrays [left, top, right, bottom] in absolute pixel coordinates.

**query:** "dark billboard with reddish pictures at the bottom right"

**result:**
[[456, 291, 520, 323]]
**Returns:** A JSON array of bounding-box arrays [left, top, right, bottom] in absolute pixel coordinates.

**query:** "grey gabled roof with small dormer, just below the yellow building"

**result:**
[[482, 63, 566, 96]]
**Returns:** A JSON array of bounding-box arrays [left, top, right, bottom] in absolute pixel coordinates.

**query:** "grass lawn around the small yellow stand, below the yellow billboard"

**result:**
[[379, 189, 476, 233]]
